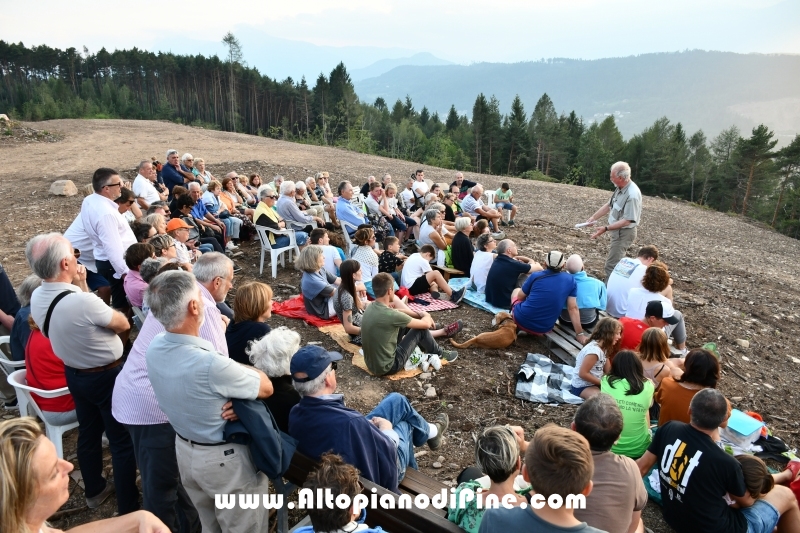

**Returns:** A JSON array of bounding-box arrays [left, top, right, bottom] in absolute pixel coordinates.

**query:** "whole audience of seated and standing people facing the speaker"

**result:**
[[0, 162, 800, 533]]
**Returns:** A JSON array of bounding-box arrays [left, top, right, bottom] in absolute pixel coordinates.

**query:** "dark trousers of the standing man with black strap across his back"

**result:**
[[65, 365, 139, 514]]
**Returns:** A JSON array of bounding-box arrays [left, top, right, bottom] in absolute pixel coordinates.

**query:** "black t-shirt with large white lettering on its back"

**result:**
[[649, 421, 747, 533]]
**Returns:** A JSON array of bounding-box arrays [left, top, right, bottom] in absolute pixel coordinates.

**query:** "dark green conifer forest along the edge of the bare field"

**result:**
[[0, 42, 800, 237]]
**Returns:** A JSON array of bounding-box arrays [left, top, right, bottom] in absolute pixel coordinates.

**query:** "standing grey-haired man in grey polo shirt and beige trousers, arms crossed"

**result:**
[[146, 271, 273, 533]]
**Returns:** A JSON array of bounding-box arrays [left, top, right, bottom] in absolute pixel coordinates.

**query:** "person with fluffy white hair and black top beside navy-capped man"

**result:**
[[247, 326, 300, 433]]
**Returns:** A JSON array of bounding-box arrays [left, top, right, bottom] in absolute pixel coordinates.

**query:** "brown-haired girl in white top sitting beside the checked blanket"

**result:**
[[569, 318, 622, 400]]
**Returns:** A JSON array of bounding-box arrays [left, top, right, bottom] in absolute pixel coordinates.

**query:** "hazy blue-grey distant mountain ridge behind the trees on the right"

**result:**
[[351, 51, 800, 140]]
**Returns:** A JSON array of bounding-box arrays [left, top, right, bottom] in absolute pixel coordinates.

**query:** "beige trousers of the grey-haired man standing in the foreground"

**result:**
[[175, 436, 269, 533]]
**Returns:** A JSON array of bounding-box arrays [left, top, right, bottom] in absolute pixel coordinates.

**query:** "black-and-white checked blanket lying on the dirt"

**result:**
[[514, 353, 583, 404]]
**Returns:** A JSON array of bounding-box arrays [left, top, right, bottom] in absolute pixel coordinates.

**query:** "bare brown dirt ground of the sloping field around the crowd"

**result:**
[[0, 120, 800, 532]]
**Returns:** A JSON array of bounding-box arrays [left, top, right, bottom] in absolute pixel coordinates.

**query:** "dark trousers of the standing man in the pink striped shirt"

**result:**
[[125, 423, 200, 533]]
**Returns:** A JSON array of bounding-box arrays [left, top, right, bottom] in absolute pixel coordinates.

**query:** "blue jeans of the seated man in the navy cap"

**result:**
[[367, 392, 431, 481]]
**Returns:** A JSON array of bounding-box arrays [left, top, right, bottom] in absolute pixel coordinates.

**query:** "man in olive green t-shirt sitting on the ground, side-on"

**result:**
[[361, 272, 458, 376]]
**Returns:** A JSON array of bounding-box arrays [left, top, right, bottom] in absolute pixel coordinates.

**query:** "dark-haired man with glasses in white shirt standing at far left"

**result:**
[[81, 168, 136, 314]]
